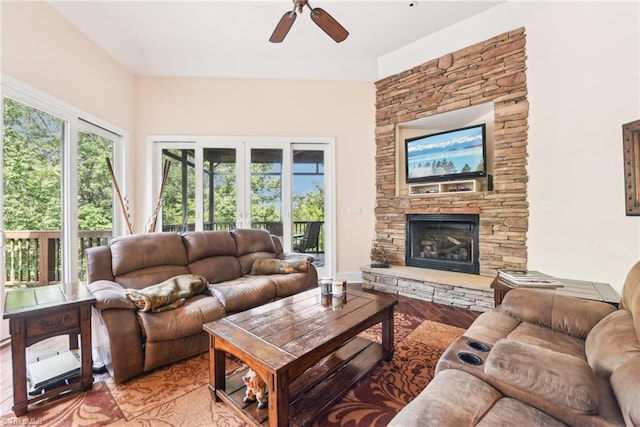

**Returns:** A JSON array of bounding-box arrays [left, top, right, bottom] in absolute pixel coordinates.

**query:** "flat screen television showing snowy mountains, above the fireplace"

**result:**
[[405, 123, 487, 183]]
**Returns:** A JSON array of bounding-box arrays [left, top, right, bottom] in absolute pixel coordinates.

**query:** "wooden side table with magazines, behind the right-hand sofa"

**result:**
[[491, 276, 620, 307]]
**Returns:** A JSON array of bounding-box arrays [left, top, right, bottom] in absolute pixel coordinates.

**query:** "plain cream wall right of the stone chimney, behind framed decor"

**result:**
[[527, 2, 640, 290]]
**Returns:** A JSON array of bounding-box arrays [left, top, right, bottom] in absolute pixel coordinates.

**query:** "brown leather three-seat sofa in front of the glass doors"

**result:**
[[86, 229, 318, 383]]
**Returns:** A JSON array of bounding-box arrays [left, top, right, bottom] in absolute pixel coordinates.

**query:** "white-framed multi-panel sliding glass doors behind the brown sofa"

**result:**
[[154, 138, 332, 275]]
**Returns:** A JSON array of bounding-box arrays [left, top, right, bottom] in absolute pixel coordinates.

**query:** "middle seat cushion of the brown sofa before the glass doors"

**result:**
[[209, 276, 276, 313]]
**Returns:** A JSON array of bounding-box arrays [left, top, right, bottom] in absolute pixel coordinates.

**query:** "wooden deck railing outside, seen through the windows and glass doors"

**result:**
[[5, 221, 324, 287]]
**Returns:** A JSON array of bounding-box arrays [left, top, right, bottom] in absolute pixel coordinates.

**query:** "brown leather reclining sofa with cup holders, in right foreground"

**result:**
[[389, 263, 640, 427]]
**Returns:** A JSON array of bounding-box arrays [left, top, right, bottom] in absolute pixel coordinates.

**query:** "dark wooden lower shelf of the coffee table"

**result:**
[[209, 336, 384, 426]]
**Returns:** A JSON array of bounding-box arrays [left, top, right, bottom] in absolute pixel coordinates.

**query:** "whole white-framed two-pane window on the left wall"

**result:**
[[0, 83, 122, 288]]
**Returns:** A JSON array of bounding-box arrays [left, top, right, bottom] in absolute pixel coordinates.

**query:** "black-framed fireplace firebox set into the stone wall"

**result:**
[[406, 214, 480, 274]]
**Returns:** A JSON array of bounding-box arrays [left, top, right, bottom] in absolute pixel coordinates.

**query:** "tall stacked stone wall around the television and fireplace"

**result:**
[[375, 28, 529, 276]]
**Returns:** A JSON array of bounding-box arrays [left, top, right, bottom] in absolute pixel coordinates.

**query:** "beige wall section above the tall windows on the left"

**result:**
[[0, 1, 135, 132]]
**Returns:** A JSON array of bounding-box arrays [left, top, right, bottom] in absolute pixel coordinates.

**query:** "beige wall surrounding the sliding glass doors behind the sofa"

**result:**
[[133, 77, 375, 272]]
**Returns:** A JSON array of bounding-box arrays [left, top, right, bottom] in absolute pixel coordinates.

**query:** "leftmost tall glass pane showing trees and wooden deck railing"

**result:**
[[2, 98, 68, 285]]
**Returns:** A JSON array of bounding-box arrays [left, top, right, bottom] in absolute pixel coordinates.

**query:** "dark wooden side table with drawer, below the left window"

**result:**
[[4, 284, 96, 417]]
